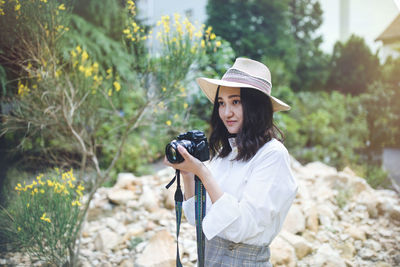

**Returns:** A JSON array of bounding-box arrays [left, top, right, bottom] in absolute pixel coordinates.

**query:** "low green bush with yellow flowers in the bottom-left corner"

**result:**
[[1, 169, 84, 266]]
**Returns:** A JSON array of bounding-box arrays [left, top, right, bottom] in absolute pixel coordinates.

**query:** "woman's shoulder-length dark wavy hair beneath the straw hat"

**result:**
[[209, 87, 284, 161]]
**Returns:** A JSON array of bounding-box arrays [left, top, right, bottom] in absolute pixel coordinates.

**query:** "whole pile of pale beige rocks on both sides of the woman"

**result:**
[[0, 159, 400, 267]]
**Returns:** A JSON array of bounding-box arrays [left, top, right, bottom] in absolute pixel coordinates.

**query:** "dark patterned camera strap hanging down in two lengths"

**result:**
[[165, 170, 206, 267]]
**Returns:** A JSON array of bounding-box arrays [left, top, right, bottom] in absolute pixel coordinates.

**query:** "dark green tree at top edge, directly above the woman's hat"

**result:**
[[207, 0, 296, 67]]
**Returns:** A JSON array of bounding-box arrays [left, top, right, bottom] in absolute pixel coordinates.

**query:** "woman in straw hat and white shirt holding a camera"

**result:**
[[165, 58, 297, 267]]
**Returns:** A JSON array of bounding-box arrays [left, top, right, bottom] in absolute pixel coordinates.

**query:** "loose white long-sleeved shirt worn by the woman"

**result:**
[[183, 138, 297, 246]]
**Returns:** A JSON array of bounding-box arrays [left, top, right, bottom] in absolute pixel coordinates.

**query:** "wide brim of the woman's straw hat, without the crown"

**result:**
[[196, 78, 290, 112]]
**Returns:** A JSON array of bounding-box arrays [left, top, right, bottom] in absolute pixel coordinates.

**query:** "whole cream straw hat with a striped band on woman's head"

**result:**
[[196, 58, 290, 112]]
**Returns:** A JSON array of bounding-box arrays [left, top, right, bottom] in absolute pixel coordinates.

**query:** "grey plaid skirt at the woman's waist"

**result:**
[[204, 236, 272, 267]]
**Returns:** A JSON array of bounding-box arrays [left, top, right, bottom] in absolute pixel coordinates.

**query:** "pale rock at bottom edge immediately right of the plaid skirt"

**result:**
[[270, 236, 296, 267]]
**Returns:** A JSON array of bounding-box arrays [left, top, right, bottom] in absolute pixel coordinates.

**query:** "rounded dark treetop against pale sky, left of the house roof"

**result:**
[[327, 35, 380, 95]]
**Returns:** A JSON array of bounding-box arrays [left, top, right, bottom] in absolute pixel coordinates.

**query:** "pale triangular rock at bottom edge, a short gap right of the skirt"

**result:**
[[312, 244, 346, 267]]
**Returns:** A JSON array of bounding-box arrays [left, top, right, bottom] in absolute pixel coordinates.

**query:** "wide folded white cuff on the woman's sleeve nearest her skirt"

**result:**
[[202, 193, 240, 240]]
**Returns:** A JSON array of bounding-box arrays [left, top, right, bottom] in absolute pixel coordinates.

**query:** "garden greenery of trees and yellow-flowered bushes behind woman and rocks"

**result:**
[[0, 0, 400, 266]]
